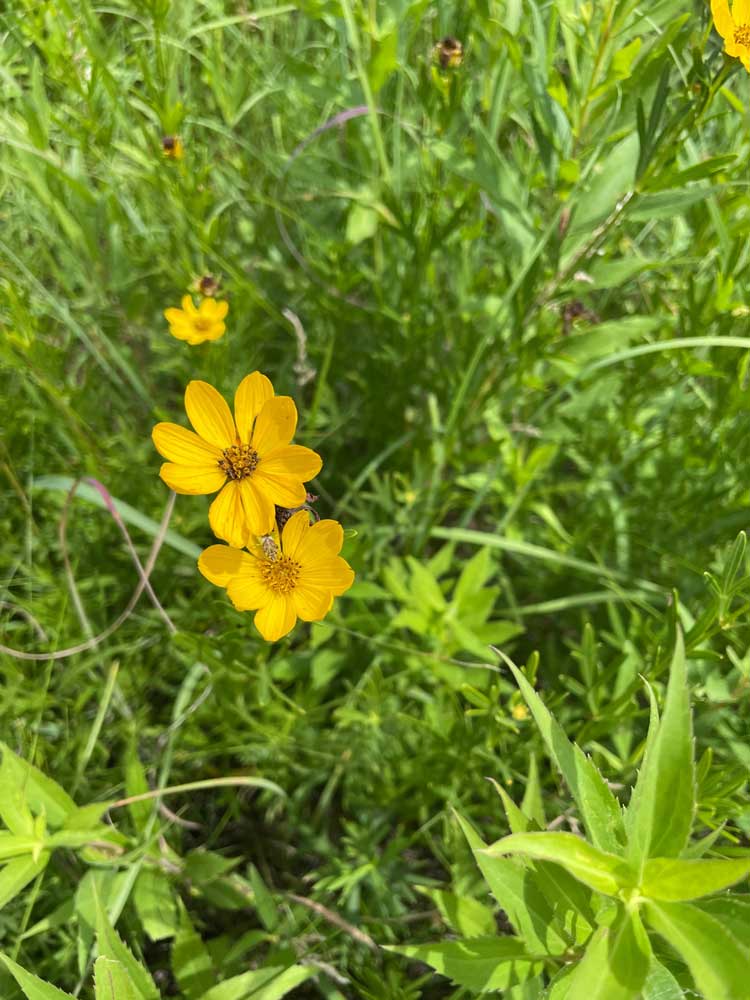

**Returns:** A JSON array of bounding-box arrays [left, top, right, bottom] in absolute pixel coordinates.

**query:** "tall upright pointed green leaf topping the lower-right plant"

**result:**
[[625, 630, 695, 867]]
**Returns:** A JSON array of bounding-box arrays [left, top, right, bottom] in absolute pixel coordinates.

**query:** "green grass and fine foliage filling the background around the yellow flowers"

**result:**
[[0, 0, 750, 1000]]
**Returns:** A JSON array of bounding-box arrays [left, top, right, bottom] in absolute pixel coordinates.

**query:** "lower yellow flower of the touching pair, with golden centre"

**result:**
[[198, 510, 354, 642]]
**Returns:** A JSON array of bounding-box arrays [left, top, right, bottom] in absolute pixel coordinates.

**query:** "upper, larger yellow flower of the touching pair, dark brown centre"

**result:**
[[151, 372, 323, 548]]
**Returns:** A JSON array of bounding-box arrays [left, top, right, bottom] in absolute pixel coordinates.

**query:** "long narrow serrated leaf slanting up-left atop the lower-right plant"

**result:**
[[506, 660, 623, 854]]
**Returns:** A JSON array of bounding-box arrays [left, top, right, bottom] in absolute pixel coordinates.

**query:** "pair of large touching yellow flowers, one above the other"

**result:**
[[152, 370, 354, 642]]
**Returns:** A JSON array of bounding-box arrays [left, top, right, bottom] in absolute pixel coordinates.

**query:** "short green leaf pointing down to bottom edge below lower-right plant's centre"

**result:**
[[562, 920, 648, 1000]]
